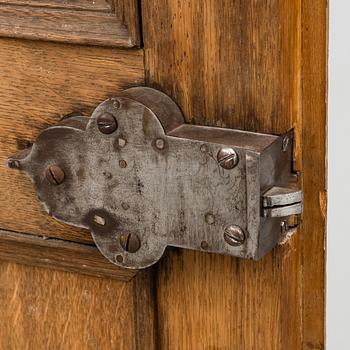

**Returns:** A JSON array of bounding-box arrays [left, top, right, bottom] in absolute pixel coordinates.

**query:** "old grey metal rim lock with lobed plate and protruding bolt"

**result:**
[[8, 87, 303, 269]]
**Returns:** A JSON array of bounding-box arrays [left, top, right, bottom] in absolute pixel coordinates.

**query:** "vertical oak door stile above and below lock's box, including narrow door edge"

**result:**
[[142, 0, 327, 350]]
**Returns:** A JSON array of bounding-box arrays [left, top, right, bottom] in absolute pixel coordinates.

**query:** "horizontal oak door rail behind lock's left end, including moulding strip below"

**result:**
[[0, 38, 144, 280]]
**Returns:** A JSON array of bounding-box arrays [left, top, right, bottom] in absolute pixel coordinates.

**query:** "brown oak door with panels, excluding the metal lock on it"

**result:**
[[0, 0, 327, 350]]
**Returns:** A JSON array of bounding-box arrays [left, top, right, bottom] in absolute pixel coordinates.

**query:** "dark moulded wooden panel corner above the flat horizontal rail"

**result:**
[[0, 0, 140, 47]]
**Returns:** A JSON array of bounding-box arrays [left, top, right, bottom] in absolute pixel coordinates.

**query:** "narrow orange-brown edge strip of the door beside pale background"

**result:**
[[302, 0, 328, 350]]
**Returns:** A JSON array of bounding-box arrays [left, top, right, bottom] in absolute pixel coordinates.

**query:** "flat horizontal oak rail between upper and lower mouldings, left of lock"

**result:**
[[0, 39, 144, 242]]
